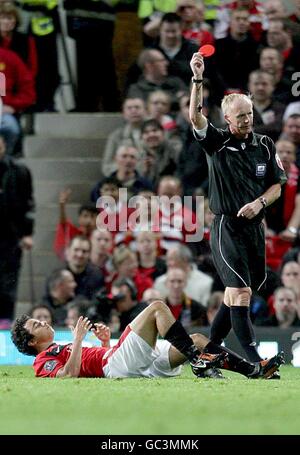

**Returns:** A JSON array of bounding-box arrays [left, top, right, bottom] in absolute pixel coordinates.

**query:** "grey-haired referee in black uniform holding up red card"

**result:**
[[190, 53, 286, 362]]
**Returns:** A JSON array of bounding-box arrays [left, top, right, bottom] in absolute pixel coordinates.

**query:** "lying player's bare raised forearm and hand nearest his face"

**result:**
[[56, 316, 92, 378]]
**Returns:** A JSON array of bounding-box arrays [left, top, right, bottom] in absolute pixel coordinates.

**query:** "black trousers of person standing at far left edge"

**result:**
[[0, 244, 22, 319]]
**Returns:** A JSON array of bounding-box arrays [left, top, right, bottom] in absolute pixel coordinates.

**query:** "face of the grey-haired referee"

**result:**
[[225, 100, 253, 138]]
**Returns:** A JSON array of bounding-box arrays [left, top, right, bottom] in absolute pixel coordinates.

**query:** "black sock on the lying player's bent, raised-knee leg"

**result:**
[[164, 321, 200, 362]]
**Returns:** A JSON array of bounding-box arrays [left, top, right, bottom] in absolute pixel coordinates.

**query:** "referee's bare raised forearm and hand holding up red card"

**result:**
[[190, 52, 207, 130]]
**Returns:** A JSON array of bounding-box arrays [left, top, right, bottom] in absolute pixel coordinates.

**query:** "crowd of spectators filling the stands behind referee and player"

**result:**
[[0, 0, 300, 332]]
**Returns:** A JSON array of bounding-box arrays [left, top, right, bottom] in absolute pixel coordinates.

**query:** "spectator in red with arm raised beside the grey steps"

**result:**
[[53, 189, 98, 260]]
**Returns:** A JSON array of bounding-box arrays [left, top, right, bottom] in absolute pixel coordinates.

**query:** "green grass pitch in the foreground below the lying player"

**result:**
[[0, 366, 300, 435]]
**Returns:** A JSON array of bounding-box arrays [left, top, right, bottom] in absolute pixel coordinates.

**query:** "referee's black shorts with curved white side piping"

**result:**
[[210, 215, 267, 290]]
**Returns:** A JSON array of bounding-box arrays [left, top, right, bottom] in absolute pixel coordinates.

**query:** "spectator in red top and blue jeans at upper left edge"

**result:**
[[0, 48, 35, 155]]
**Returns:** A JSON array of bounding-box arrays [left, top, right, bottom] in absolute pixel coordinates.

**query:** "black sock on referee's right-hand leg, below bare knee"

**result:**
[[231, 306, 261, 362]]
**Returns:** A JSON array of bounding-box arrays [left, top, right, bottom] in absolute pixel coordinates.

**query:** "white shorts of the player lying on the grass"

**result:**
[[103, 327, 181, 378]]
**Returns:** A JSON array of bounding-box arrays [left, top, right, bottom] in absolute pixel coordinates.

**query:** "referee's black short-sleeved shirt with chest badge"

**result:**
[[195, 123, 287, 221]]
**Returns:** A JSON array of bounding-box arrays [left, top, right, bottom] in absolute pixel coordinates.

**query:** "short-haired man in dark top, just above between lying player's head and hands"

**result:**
[[43, 269, 77, 327]]
